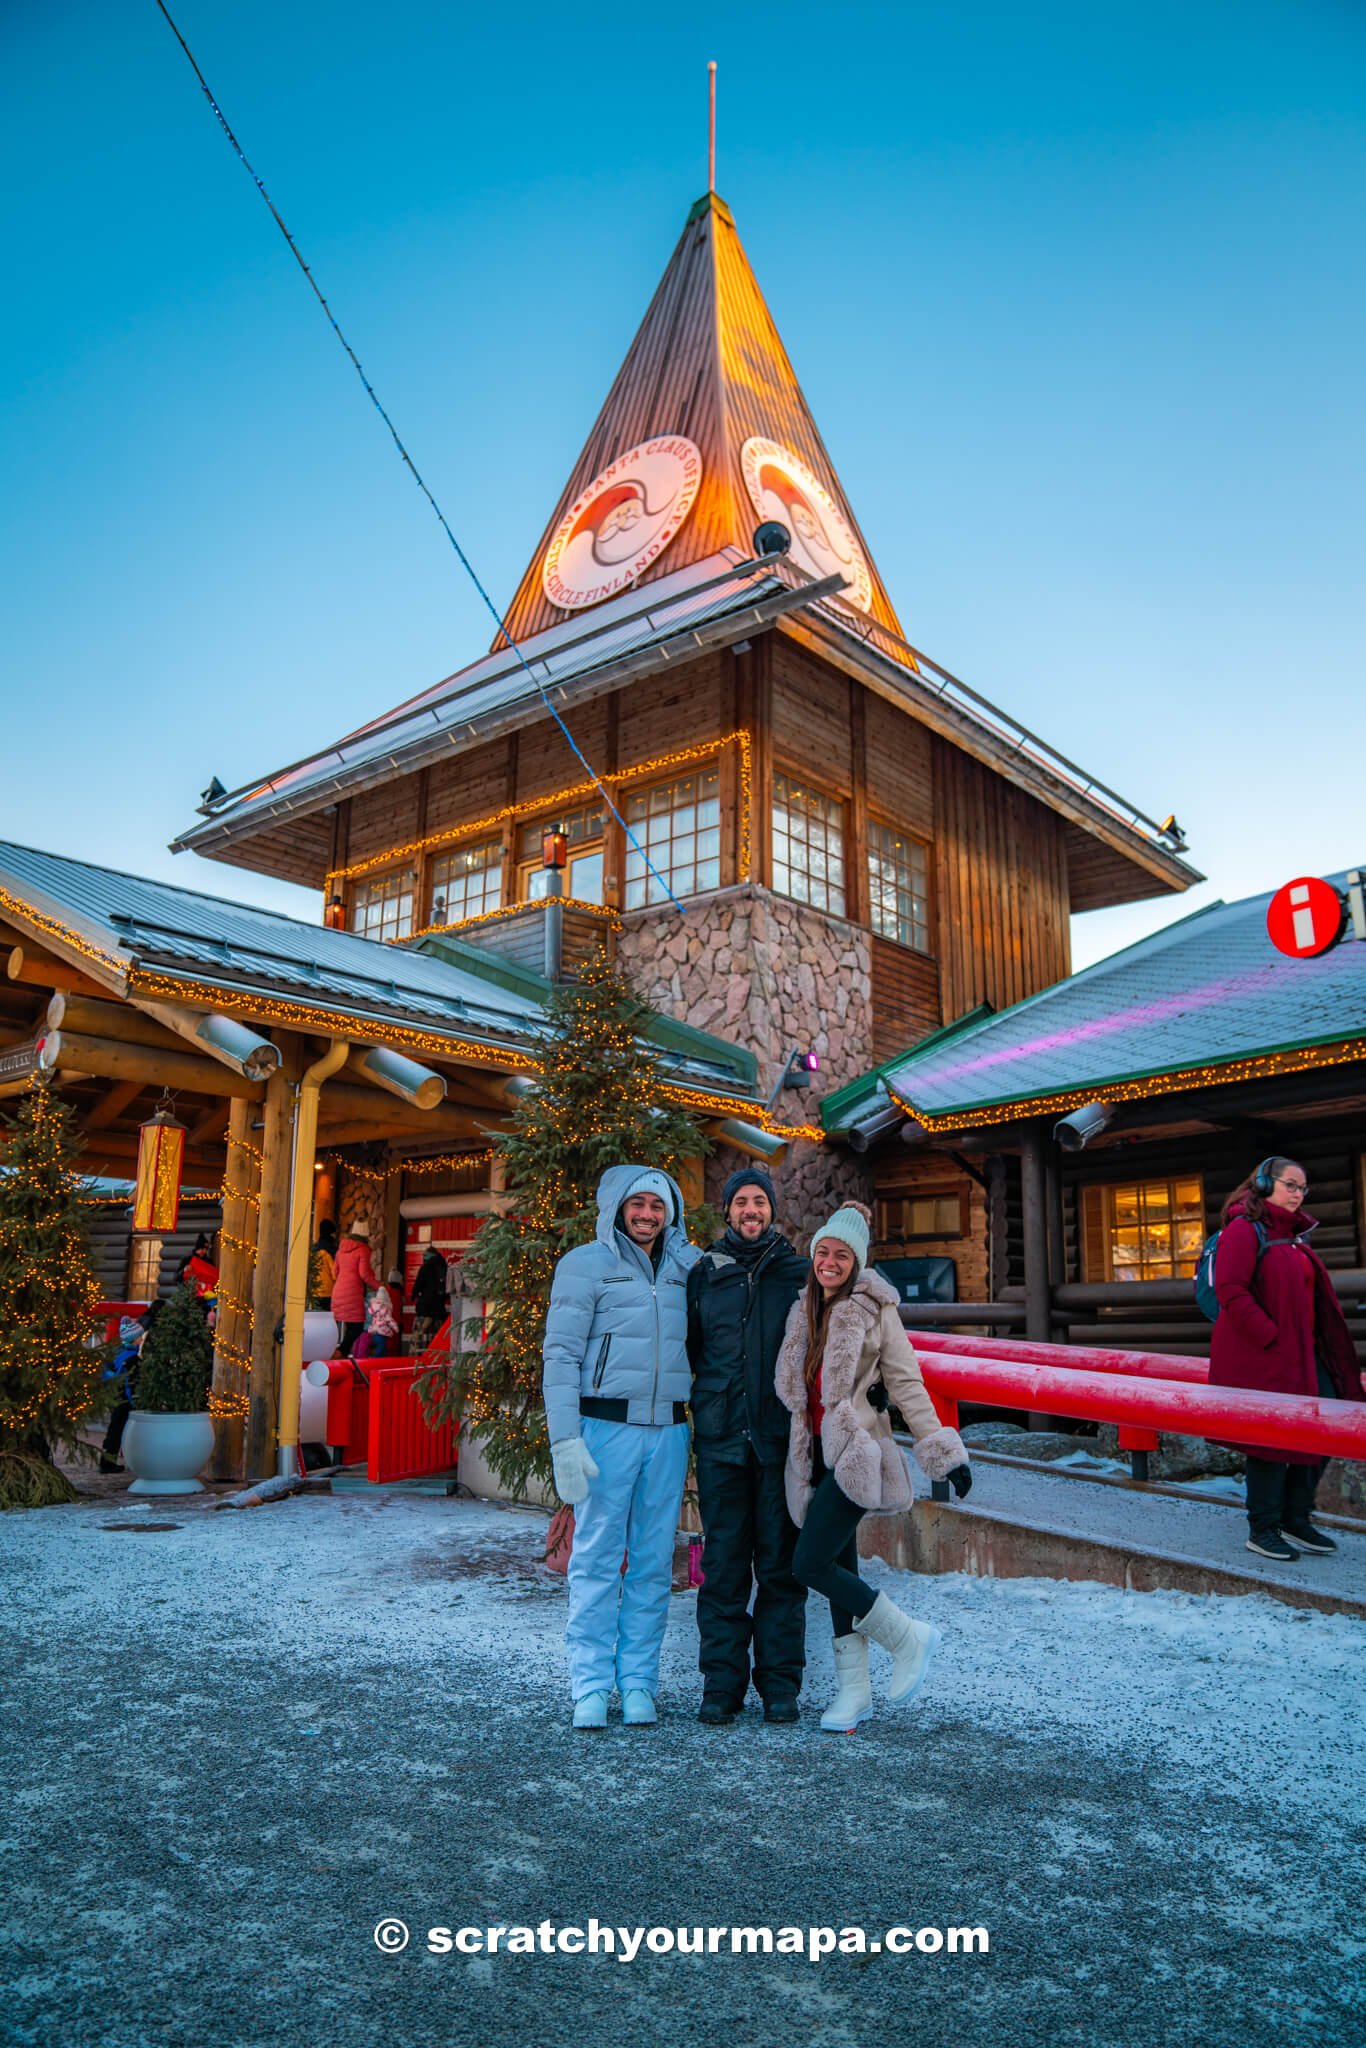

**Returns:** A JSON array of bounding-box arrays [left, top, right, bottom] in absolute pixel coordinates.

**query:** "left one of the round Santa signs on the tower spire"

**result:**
[[541, 434, 702, 612]]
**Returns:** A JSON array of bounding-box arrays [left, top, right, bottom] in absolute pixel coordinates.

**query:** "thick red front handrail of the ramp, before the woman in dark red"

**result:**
[[920, 1346, 1366, 1462]]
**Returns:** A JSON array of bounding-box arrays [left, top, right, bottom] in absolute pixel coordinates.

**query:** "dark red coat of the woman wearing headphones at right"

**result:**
[[1210, 1202, 1366, 1464]]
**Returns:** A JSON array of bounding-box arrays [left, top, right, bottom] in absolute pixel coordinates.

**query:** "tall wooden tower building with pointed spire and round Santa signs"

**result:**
[[167, 193, 1198, 1231]]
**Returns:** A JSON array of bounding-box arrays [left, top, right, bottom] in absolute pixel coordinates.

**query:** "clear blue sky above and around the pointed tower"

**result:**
[[0, 0, 1366, 965]]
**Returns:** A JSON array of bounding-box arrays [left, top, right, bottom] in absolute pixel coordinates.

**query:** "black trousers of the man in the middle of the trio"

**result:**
[[696, 1444, 807, 1706]]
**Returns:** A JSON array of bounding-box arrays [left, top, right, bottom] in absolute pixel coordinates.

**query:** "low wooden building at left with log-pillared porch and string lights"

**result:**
[[0, 844, 782, 1477]]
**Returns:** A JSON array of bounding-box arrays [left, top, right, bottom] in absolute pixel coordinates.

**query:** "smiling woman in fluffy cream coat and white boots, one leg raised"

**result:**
[[774, 1202, 973, 1735]]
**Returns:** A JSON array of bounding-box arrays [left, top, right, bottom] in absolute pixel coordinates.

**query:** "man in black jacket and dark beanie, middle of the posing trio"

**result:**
[[688, 1165, 809, 1726]]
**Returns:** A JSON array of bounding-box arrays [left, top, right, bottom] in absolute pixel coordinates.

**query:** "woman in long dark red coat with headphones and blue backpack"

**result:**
[[1210, 1159, 1364, 1563]]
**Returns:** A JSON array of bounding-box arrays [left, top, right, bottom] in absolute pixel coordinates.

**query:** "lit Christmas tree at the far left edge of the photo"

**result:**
[[0, 1081, 113, 1507]]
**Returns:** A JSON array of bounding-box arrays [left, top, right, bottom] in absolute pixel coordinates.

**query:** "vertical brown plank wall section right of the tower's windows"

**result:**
[[934, 739, 1071, 1020]]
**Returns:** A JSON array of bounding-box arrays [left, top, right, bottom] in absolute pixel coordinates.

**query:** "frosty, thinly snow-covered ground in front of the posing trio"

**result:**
[[0, 1493, 1366, 2048]]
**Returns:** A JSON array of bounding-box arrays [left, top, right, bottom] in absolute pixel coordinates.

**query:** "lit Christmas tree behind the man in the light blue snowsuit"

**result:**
[[420, 952, 715, 1497]]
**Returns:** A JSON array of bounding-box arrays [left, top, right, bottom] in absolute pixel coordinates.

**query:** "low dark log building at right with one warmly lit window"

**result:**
[[823, 877, 1366, 1356]]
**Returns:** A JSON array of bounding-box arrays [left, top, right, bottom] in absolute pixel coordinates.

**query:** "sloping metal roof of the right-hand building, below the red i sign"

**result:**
[[821, 874, 1366, 1130]]
